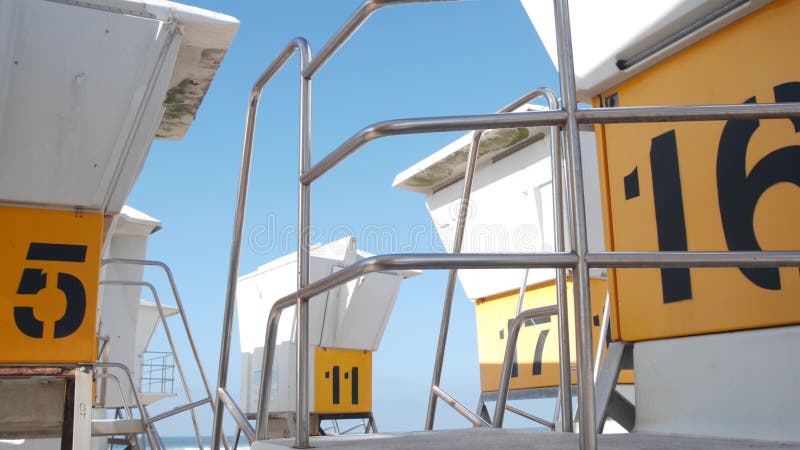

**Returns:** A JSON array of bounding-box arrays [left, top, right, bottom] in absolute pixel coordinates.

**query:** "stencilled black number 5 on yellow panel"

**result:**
[[14, 242, 86, 339]]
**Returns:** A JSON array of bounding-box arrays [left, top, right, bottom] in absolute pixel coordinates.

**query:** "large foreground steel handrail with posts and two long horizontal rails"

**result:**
[[212, 0, 800, 450]]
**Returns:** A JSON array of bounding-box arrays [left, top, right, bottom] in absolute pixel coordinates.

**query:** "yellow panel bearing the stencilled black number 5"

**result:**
[[0, 207, 103, 363]]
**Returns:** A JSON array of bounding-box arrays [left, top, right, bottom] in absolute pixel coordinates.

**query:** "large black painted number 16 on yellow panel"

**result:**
[[623, 82, 800, 303]]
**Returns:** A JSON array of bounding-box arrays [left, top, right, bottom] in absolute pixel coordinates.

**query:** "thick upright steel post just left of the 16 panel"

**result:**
[[553, 0, 597, 450]]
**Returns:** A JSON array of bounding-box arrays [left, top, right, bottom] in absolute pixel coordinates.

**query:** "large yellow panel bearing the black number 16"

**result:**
[[598, 1, 800, 341]]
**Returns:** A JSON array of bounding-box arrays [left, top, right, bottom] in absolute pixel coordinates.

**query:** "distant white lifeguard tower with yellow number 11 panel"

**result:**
[[236, 237, 419, 437]]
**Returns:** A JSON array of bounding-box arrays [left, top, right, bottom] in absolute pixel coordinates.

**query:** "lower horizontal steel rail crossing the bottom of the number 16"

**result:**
[[586, 251, 800, 268]]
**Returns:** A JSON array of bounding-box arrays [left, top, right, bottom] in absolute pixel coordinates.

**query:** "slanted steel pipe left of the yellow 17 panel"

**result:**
[[425, 131, 483, 430]]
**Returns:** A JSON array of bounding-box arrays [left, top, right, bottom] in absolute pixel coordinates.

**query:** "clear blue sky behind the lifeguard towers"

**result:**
[[128, 0, 558, 435]]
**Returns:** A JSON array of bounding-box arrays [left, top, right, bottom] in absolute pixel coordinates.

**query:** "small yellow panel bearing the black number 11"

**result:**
[[314, 348, 372, 413]]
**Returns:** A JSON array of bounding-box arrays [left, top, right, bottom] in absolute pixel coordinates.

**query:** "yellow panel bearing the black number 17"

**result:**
[[475, 279, 633, 392]]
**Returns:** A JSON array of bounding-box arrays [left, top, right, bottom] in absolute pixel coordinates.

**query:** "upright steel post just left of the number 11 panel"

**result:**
[[296, 68, 311, 448]]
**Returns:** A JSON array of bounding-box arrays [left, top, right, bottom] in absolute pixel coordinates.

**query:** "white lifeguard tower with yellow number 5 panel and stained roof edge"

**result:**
[[0, 0, 238, 450]]
